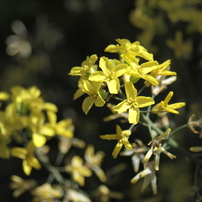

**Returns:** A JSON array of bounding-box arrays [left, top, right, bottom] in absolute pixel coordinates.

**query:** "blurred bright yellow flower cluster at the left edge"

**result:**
[[0, 86, 73, 175]]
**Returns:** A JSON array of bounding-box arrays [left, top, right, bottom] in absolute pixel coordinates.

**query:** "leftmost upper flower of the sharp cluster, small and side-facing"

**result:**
[[69, 55, 98, 79]]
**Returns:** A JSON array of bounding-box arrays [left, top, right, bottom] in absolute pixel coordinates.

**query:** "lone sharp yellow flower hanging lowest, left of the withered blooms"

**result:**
[[100, 125, 132, 158]]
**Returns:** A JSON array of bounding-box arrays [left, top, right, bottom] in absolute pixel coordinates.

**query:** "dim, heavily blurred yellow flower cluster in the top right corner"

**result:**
[[130, 0, 202, 59]]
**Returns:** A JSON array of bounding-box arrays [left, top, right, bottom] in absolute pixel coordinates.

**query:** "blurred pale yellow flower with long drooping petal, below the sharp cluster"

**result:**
[[85, 145, 107, 182]]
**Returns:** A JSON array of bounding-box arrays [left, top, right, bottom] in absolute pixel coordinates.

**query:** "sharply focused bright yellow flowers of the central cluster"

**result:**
[[69, 39, 185, 158]]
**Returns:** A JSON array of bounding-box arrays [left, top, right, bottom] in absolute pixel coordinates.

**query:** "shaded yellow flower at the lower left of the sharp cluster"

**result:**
[[82, 80, 105, 114]]
